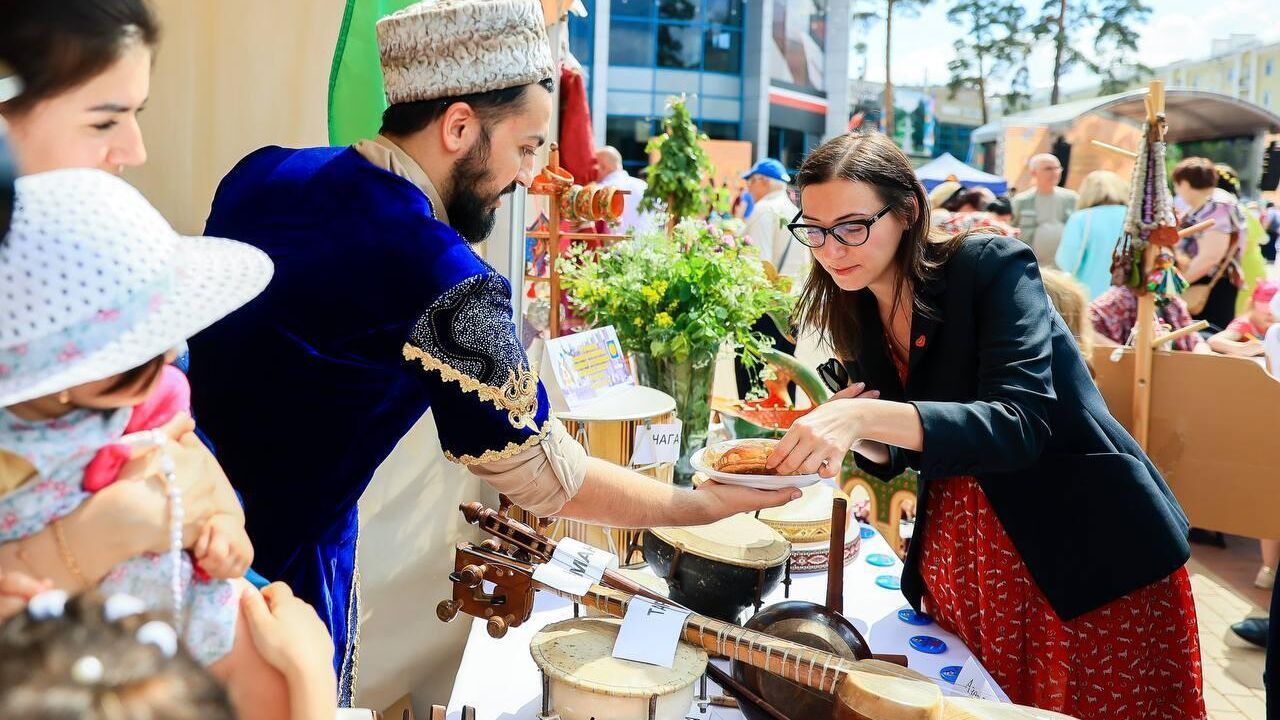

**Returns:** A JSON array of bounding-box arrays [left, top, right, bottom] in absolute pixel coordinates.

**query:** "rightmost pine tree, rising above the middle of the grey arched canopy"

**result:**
[[1032, 0, 1151, 105]]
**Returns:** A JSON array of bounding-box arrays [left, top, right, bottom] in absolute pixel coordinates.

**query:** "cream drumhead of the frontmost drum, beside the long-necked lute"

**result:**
[[529, 609, 707, 697]]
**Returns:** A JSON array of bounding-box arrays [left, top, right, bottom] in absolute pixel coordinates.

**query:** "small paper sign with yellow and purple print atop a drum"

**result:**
[[539, 325, 635, 413]]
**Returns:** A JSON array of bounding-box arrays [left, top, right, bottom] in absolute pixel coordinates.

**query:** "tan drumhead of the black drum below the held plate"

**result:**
[[649, 515, 791, 568]]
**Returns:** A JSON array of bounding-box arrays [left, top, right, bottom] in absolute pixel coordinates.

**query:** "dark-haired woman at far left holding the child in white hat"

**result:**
[[0, 0, 240, 619]]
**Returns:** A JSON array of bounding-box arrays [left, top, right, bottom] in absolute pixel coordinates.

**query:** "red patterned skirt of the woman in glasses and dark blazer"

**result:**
[[920, 477, 1206, 720]]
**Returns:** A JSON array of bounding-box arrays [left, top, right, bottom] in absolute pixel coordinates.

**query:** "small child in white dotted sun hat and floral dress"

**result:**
[[0, 169, 335, 717]]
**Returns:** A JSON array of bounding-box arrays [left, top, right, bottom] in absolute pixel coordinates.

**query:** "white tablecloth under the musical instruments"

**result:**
[[448, 525, 1009, 720]]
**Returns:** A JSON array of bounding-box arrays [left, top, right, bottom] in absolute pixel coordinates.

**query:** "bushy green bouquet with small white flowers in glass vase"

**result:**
[[561, 218, 792, 365]]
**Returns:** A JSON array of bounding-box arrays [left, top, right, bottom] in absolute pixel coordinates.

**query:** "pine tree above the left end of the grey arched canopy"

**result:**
[[947, 0, 1030, 124]]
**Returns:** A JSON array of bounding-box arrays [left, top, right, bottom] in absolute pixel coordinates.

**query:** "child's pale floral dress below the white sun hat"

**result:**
[[0, 409, 238, 665]]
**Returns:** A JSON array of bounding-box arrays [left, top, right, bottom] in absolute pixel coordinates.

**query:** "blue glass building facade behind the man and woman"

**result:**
[[568, 0, 850, 172]]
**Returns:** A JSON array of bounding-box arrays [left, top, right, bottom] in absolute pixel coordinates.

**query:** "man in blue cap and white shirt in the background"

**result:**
[[735, 158, 793, 396]]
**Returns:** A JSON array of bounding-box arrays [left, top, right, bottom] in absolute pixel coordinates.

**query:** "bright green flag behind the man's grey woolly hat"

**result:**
[[329, 0, 417, 145]]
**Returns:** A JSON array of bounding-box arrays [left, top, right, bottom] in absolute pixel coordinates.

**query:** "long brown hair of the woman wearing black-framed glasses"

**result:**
[[794, 133, 965, 360]]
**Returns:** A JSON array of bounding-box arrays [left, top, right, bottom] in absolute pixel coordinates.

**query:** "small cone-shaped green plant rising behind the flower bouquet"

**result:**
[[640, 96, 716, 223]]
